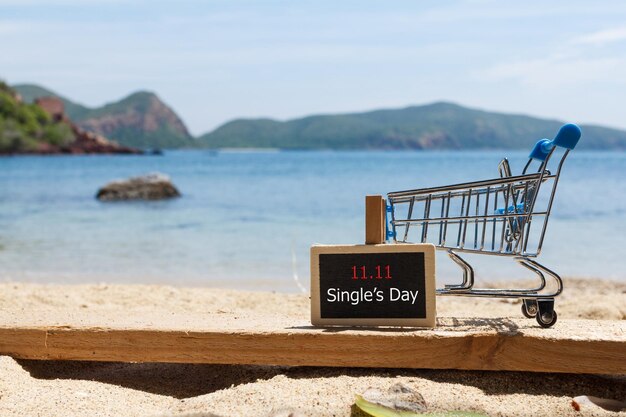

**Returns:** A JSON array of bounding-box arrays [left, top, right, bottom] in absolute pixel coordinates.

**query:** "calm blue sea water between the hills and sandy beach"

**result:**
[[0, 151, 626, 291]]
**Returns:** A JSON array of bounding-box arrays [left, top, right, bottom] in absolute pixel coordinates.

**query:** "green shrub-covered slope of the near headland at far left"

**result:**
[[0, 81, 75, 154]]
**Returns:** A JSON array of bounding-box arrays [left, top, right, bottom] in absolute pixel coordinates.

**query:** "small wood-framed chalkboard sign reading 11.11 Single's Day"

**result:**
[[311, 244, 435, 327]]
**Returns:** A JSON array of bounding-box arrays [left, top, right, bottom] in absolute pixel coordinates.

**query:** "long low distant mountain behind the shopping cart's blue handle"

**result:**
[[198, 102, 626, 150]]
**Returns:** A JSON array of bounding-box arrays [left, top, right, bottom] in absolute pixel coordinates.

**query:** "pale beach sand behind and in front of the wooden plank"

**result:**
[[0, 279, 626, 417]]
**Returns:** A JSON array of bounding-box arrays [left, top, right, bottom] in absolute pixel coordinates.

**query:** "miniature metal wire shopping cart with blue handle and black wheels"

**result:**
[[387, 124, 581, 327]]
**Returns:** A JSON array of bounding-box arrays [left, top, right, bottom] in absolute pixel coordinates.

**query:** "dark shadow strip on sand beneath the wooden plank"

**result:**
[[18, 358, 626, 399]]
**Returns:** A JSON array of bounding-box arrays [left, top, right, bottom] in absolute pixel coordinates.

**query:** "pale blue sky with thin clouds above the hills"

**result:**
[[0, 0, 626, 134]]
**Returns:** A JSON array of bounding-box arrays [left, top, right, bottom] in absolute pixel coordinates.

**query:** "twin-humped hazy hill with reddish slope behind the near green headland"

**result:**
[[13, 84, 196, 149]]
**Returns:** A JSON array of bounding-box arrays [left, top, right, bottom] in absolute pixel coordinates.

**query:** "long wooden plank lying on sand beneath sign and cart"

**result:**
[[0, 311, 626, 374]]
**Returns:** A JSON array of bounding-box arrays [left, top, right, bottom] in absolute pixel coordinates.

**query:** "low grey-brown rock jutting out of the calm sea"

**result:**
[[96, 173, 180, 201]]
